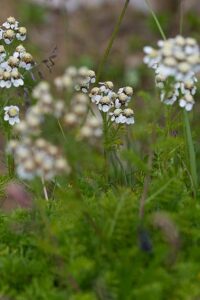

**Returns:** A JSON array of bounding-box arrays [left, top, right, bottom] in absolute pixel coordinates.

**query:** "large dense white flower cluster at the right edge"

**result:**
[[144, 35, 200, 111]]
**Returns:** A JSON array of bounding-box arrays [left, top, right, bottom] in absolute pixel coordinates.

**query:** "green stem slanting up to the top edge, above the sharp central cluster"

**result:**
[[96, 0, 130, 82]]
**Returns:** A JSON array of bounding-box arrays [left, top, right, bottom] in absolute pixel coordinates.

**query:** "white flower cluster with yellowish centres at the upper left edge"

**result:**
[[0, 17, 35, 88]]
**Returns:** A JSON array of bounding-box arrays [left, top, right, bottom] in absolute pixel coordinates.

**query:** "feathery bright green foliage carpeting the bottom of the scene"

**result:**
[[0, 177, 200, 299]]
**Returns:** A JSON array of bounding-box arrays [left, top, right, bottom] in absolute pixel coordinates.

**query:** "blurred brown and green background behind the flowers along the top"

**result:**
[[0, 0, 200, 84]]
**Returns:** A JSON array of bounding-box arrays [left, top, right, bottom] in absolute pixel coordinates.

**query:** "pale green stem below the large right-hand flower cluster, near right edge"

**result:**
[[183, 110, 198, 197]]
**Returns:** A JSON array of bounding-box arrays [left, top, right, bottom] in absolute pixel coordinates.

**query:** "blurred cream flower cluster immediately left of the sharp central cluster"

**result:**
[[54, 66, 102, 144]]
